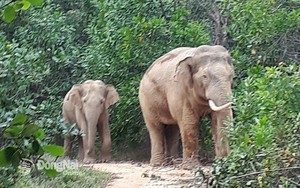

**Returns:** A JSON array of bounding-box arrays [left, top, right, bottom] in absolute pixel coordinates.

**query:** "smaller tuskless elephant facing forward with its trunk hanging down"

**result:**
[[62, 80, 119, 163]]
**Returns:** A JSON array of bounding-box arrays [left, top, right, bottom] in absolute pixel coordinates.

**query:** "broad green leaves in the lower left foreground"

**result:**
[[0, 114, 63, 185]]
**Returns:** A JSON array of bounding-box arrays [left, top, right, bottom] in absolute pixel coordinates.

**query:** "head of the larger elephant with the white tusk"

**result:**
[[175, 45, 234, 111]]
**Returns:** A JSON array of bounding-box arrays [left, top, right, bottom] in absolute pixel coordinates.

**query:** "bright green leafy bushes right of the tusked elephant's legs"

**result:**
[[213, 65, 300, 187]]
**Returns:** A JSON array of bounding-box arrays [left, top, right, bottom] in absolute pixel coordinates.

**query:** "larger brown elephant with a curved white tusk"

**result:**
[[139, 45, 234, 168]]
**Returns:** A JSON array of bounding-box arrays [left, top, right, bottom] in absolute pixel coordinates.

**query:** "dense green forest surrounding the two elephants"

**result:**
[[0, 0, 300, 187]]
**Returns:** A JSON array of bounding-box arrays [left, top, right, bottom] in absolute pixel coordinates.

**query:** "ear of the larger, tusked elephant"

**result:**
[[173, 48, 197, 87]]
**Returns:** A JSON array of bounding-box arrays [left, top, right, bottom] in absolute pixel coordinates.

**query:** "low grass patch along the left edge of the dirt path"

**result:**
[[16, 168, 111, 188]]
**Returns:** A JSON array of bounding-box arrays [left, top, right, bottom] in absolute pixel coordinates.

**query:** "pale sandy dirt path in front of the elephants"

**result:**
[[89, 162, 210, 188]]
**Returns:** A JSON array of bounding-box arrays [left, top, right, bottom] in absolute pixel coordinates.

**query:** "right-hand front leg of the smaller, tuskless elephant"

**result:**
[[98, 114, 111, 162]]
